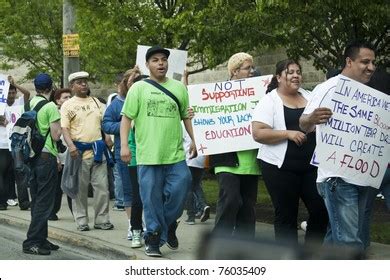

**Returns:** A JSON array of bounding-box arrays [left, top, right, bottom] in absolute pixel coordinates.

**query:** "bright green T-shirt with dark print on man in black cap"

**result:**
[[122, 79, 189, 165]]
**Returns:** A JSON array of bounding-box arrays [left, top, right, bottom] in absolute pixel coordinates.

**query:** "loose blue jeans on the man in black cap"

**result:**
[[138, 160, 191, 245]]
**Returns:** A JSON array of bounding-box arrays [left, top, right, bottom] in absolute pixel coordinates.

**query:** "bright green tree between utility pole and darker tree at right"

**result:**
[[74, 0, 272, 82]]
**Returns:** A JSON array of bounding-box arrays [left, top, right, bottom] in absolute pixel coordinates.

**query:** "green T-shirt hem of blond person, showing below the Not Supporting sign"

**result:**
[[215, 150, 260, 175]]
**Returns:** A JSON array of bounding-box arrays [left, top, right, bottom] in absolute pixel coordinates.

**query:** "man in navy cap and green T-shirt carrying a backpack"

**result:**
[[23, 73, 61, 255]]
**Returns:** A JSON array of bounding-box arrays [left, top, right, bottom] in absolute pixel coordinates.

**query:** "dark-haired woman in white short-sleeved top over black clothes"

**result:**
[[252, 59, 328, 243]]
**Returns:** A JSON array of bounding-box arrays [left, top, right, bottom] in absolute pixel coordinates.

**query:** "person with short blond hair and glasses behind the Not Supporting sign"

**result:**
[[210, 52, 260, 238]]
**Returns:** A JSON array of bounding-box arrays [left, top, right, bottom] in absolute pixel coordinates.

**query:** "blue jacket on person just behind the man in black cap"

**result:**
[[102, 95, 125, 160]]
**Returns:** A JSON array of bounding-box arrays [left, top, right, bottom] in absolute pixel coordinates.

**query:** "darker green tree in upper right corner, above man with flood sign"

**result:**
[[257, 0, 390, 70]]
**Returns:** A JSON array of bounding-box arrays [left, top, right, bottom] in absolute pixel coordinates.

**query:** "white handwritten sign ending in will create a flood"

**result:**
[[316, 76, 390, 188]]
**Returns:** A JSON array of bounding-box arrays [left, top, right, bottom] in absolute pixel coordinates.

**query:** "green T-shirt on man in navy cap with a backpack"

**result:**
[[30, 96, 61, 156]]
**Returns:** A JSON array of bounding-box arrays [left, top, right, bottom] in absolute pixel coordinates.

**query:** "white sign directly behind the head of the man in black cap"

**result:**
[[136, 45, 188, 81]]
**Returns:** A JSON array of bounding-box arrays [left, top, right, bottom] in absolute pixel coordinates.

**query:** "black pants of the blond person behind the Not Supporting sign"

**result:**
[[214, 172, 258, 238]]
